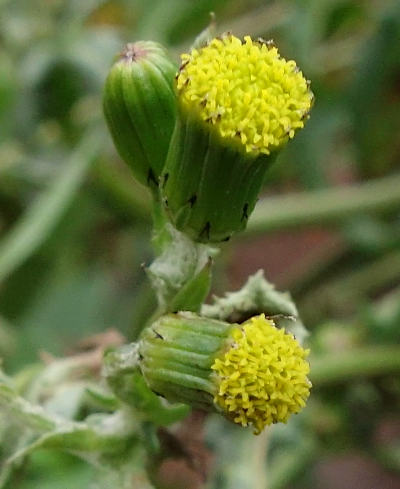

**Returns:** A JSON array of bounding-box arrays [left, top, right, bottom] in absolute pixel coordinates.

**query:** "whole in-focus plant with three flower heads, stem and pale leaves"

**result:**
[[0, 29, 313, 489]]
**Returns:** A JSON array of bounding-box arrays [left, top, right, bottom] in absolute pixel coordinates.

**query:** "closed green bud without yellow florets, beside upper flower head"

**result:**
[[103, 41, 176, 186]]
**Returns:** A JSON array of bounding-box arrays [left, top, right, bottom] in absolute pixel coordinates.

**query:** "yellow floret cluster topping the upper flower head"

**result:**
[[177, 35, 313, 155]]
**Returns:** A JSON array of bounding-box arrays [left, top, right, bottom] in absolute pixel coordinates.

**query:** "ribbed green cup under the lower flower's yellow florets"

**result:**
[[139, 312, 234, 411]]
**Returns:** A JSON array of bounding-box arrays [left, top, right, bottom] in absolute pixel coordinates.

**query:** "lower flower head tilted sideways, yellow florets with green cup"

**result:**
[[139, 313, 311, 433]]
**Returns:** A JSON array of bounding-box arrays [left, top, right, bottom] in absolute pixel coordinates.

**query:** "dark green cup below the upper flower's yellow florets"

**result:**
[[161, 108, 275, 243]]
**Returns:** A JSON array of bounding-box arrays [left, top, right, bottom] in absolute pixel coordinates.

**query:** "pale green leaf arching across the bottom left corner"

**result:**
[[0, 378, 155, 489]]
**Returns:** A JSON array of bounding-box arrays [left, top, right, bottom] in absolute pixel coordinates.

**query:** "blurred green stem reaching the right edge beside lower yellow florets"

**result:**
[[310, 345, 400, 387]]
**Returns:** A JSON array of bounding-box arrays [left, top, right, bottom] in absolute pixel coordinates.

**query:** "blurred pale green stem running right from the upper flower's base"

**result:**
[[247, 175, 400, 236]]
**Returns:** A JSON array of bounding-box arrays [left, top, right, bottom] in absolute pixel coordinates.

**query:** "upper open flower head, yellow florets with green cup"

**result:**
[[162, 35, 313, 242]]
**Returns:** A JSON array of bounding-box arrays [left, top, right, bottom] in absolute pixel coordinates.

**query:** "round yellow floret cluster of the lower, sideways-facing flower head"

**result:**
[[211, 314, 311, 433]]
